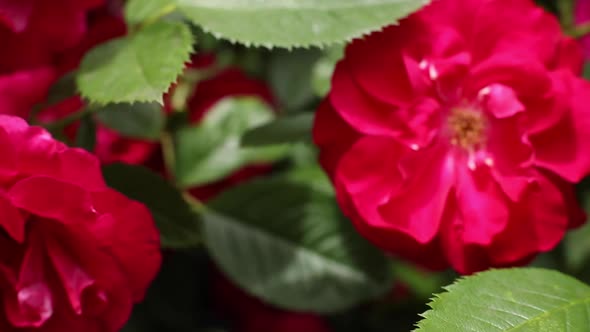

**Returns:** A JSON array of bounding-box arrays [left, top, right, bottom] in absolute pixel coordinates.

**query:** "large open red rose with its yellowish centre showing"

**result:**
[[314, 0, 590, 273]]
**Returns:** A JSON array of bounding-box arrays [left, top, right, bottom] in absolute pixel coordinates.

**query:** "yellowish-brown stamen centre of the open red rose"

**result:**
[[448, 107, 486, 150]]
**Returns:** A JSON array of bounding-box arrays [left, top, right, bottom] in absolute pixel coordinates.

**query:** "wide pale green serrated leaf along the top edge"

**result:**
[[176, 0, 428, 47]]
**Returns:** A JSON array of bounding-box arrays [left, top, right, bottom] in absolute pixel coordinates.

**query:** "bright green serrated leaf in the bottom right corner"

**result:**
[[417, 268, 590, 332]]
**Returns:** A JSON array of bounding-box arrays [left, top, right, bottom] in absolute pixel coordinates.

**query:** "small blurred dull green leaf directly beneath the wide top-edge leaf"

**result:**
[[268, 48, 322, 111]]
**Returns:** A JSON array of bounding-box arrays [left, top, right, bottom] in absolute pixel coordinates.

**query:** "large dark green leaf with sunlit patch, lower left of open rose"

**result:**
[[203, 178, 392, 313]]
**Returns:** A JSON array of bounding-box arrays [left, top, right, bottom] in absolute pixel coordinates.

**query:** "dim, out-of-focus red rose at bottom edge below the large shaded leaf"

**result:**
[[214, 273, 331, 332]]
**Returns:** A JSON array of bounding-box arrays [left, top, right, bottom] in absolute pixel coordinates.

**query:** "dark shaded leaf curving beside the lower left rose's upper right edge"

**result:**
[[103, 164, 200, 248]]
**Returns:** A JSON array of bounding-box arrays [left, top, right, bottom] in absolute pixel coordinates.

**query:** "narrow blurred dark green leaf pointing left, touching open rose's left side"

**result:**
[[242, 113, 314, 146]]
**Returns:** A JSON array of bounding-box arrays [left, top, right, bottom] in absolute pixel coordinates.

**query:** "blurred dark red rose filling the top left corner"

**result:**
[[0, 0, 104, 117]]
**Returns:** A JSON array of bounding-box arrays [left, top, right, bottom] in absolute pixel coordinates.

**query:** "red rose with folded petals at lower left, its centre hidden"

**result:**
[[0, 116, 161, 332]]
